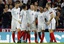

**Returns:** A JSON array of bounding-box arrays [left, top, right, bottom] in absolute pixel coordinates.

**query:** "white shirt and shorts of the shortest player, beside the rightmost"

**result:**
[[38, 12, 45, 32]]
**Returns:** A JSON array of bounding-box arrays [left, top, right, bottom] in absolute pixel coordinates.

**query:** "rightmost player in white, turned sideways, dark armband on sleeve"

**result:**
[[46, 3, 56, 42]]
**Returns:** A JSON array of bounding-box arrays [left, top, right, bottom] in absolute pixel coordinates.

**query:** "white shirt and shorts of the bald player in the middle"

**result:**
[[27, 9, 36, 30]]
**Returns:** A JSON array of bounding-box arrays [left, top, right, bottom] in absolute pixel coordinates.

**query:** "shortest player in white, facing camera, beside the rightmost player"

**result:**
[[38, 7, 45, 43]]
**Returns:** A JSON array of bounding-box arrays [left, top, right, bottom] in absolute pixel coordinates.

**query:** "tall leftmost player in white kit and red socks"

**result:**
[[11, 2, 20, 42]]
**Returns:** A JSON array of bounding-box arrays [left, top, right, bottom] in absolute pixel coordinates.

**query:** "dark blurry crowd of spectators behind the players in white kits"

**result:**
[[0, 0, 64, 28]]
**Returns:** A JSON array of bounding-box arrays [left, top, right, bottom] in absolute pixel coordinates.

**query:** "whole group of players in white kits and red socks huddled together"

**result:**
[[11, 2, 56, 43]]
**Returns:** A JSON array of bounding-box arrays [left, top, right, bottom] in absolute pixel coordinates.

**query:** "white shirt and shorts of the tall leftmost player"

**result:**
[[11, 8, 20, 31]]
